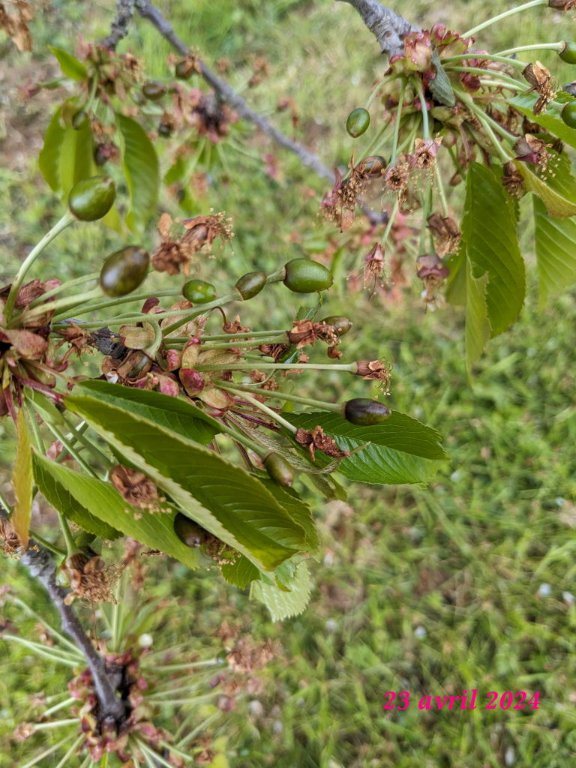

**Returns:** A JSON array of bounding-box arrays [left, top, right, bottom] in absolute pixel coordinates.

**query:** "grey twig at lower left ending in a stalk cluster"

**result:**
[[0, 502, 126, 723]]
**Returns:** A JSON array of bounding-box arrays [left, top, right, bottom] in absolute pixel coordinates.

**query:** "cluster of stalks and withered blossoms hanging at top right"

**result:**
[[322, 0, 576, 308]]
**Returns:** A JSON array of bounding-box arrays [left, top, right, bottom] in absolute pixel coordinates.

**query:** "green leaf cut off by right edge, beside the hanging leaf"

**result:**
[[534, 198, 576, 306]]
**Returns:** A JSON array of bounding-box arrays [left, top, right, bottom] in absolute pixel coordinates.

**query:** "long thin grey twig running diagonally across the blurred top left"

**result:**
[[135, 0, 335, 183]]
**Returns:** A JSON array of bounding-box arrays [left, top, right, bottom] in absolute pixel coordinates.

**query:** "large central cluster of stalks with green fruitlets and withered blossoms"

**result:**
[[0, 176, 390, 520]]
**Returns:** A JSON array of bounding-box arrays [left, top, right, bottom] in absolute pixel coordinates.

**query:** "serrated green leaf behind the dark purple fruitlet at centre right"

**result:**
[[286, 411, 447, 485]]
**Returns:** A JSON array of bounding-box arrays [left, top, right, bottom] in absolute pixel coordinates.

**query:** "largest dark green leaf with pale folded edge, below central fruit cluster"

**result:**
[[66, 393, 306, 570]]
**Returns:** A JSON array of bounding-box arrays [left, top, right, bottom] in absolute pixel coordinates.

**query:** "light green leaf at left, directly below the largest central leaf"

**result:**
[[34, 454, 200, 568]]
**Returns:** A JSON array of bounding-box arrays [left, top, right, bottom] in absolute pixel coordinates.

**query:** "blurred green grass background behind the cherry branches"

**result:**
[[0, 0, 576, 768]]
